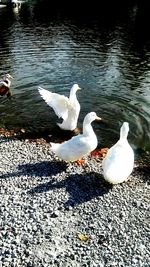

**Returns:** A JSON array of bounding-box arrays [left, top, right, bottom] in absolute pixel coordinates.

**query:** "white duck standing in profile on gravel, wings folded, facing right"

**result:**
[[50, 112, 101, 162]]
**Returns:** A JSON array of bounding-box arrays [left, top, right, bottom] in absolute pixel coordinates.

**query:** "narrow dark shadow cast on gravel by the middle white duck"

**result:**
[[0, 161, 67, 179]]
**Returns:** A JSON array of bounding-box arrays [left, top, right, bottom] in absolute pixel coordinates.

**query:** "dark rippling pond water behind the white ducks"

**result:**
[[0, 3, 150, 153]]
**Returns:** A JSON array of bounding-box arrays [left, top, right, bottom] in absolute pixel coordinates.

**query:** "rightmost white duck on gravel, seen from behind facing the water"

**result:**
[[102, 122, 134, 184]]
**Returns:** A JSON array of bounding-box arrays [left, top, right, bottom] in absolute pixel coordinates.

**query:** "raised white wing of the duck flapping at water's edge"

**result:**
[[38, 87, 70, 120]]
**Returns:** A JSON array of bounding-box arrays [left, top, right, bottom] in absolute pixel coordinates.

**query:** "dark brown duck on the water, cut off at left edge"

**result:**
[[0, 74, 13, 95]]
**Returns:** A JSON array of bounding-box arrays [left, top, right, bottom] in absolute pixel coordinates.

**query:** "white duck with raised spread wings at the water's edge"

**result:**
[[38, 84, 81, 131]]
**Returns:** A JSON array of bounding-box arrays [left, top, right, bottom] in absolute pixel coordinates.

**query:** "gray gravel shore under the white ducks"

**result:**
[[0, 136, 150, 267]]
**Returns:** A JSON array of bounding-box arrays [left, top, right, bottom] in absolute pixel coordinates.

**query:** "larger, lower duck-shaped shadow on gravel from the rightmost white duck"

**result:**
[[28, 172, 112, 209]]
